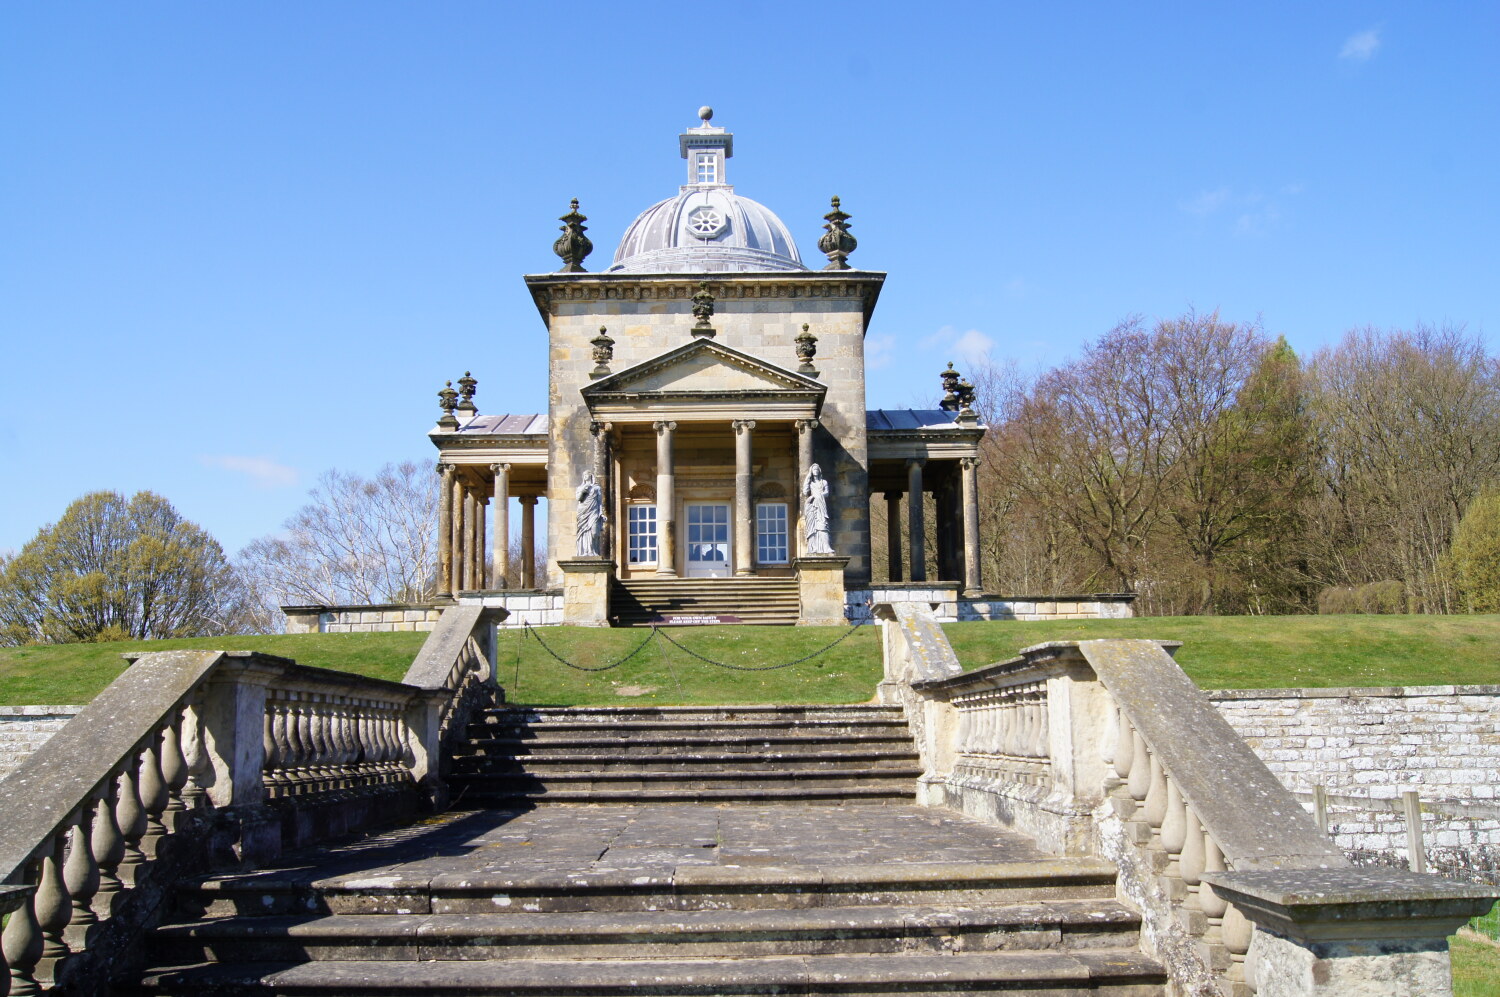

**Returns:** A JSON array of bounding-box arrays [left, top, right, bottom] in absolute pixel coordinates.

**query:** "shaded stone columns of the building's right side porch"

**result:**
[[885, 457, 981, 592]]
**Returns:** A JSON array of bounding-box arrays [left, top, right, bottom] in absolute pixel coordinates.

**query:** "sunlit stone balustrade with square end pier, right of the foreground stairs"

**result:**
[[876, 604, 1500, 997]]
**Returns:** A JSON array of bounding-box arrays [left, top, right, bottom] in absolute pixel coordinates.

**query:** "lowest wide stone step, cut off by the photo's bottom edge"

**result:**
[[141, 949, 1166, 997]]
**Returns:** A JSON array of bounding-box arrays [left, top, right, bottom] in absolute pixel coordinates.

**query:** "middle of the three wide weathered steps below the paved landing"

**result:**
[[150, 900, 1140, 964]]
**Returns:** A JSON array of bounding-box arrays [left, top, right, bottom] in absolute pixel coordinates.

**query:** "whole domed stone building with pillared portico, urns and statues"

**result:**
[[414, 108, 1068, 624]]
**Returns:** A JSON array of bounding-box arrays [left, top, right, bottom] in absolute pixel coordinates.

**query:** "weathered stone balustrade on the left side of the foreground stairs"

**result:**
[[0, 607, 497, 996]]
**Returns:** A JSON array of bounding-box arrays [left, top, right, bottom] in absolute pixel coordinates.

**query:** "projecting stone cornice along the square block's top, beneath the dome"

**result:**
[[525, 270, 885, 325]]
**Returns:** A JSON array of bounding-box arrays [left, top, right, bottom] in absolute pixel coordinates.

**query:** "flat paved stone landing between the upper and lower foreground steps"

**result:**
[[199, 804, 1052, 894]]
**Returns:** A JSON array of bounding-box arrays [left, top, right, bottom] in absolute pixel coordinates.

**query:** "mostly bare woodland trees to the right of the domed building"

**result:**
[[876, 313, 1500, 615]]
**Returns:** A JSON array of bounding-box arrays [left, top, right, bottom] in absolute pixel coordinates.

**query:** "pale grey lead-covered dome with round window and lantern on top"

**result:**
[[608, 108, 807, 273]]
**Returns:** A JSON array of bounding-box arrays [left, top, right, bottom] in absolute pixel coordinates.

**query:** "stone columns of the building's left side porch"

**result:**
[[437, 463, 537, 597]]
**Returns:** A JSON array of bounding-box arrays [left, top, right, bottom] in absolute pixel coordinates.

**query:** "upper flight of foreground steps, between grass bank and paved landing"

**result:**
[[449, 706, 921, 807]]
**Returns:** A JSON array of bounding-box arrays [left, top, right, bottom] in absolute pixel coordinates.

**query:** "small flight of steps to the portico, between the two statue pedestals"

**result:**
[[609, 579, 801, 627]]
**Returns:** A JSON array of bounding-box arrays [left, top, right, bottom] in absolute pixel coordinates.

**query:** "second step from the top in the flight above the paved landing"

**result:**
[[453, 730, 912, 759]]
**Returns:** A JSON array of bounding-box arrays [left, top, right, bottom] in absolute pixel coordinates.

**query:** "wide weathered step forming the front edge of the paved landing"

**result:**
[[187, 850, 1115, 918]]
